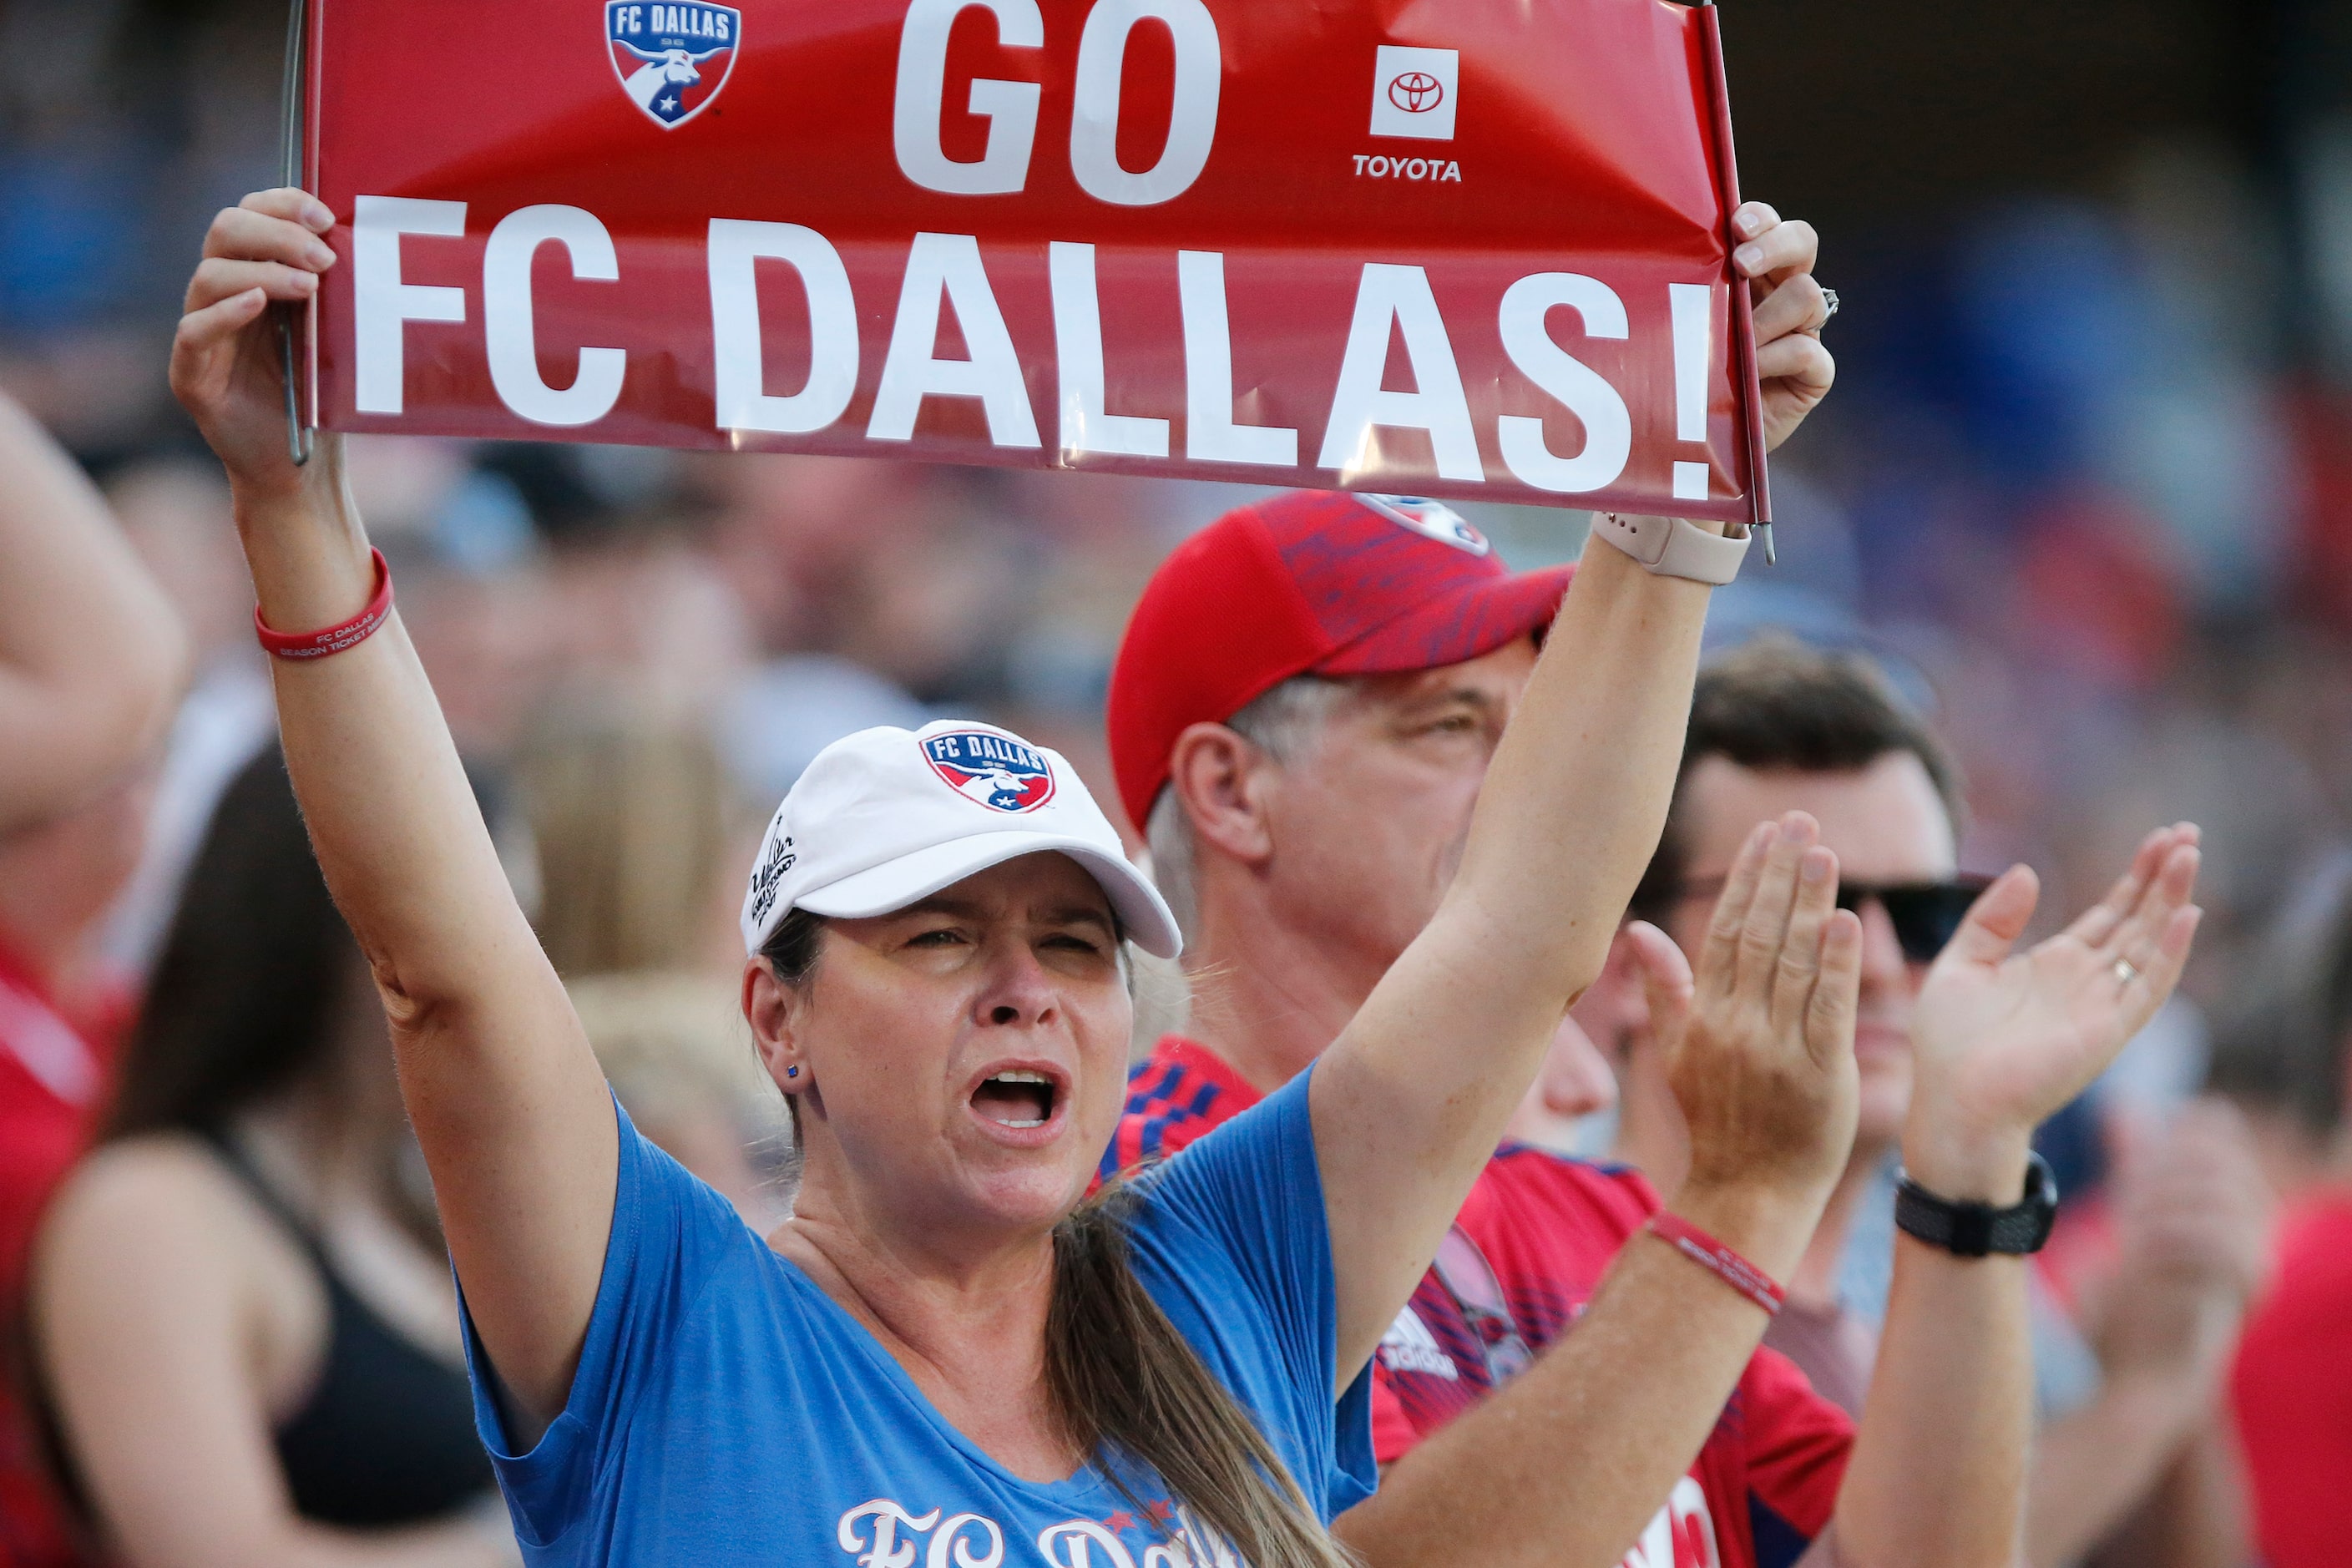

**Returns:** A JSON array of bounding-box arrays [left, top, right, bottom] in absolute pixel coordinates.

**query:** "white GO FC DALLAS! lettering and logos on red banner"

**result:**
[[331, 0, 1717, 501]]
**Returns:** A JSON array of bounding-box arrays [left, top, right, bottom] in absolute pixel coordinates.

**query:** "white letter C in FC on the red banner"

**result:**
[[482, 205, 628, 427]]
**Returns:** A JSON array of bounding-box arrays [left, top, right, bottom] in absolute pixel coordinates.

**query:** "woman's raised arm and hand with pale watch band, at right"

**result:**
[[1313, 202, 1832, 1375]]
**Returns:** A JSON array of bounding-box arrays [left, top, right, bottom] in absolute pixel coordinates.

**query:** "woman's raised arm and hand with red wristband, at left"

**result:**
[[172, 190, 619, 1424]]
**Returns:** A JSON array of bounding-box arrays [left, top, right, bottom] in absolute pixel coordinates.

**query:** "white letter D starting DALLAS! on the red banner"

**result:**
[[708, 219, 858, 432]]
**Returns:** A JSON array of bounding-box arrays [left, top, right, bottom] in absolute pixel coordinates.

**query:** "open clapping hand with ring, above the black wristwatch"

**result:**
[[1903, 822, 2202, 1204]]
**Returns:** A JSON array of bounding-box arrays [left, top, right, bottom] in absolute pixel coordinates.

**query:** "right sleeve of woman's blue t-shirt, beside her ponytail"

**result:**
[[1134, 1070, 1378, 1521]]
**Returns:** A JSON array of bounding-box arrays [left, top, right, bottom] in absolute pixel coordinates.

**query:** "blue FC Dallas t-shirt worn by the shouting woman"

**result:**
[[466, 1075, 1376, 1568]]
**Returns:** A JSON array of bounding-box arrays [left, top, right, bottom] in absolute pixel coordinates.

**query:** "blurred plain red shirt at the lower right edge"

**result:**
[[2230, 1192, 2352, 1568]]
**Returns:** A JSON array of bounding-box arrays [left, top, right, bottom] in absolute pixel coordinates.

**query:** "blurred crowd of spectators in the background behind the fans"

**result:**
[[0, 0, 2352, 1568]]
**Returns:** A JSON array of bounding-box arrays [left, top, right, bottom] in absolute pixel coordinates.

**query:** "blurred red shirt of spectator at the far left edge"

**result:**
[[0, 952, 99, 1568]]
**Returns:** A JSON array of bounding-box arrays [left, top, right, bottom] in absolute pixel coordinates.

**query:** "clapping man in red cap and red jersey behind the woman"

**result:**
[[1103, 474, 2197, 1568]]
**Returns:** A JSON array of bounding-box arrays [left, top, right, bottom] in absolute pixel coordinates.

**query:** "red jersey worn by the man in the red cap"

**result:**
[[1103, 1034, 1854, 1568]]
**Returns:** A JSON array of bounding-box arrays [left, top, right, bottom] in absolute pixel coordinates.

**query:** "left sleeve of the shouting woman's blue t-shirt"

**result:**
[[458, 1103, 751, 1547]]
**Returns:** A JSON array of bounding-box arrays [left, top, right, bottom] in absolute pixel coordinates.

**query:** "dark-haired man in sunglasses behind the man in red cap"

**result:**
[[1608, 637, 2265, 1568]]
